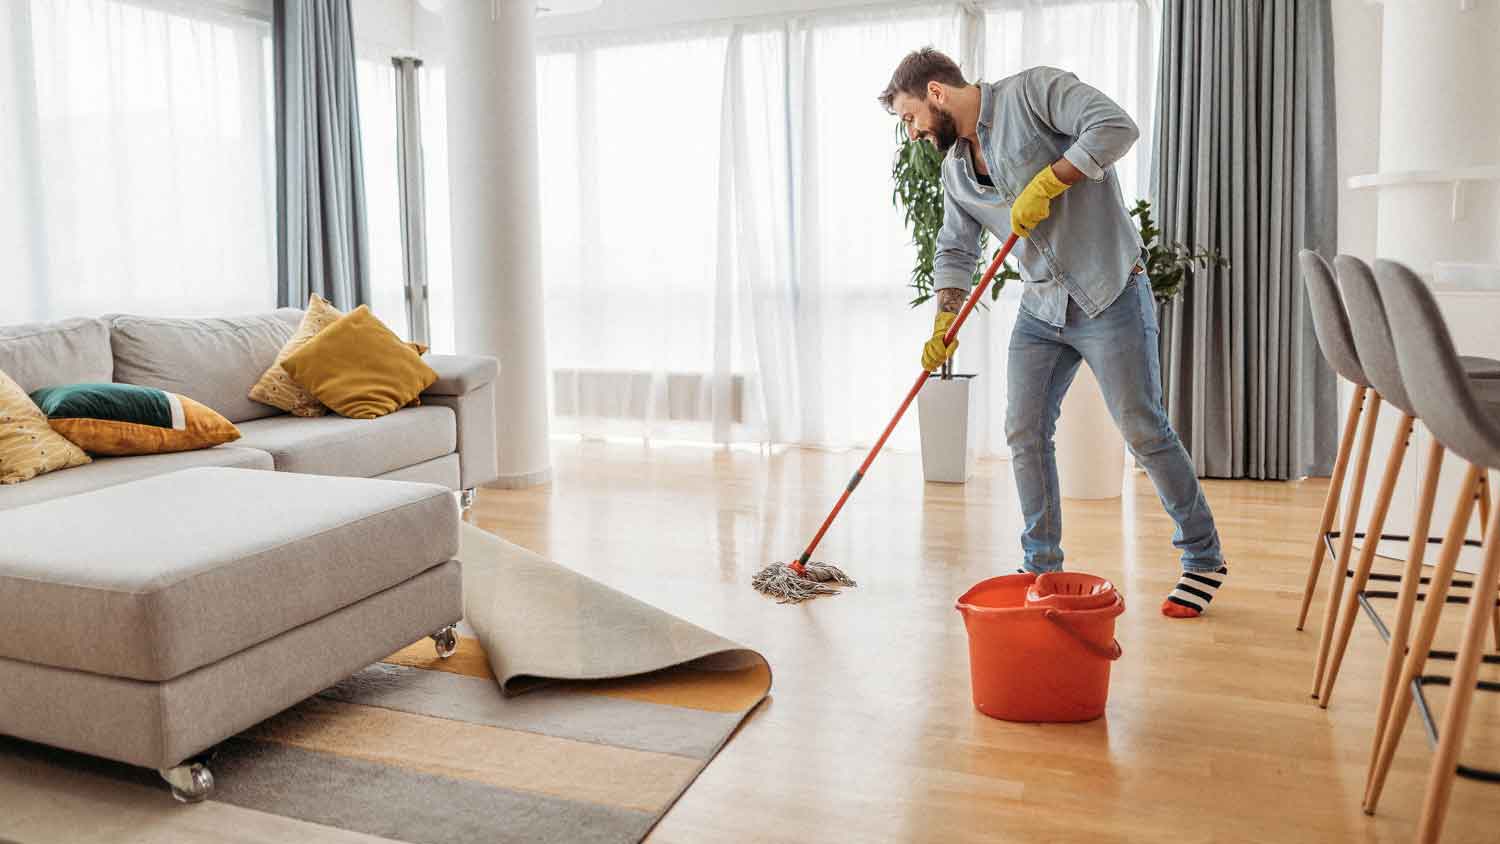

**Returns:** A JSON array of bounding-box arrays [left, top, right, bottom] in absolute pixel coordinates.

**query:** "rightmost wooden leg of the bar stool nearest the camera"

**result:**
[[1418, 497, 1500, 843]]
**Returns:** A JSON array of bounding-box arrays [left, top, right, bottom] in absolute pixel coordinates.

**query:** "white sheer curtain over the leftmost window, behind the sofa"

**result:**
[[0, 0, 276, 322]]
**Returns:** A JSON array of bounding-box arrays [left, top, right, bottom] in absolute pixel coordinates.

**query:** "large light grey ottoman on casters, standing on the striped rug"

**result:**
[[0, 468, 464, 801]]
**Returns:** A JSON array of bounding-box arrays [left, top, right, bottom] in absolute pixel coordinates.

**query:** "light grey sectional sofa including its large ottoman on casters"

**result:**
[[0, 310, 498, 801]]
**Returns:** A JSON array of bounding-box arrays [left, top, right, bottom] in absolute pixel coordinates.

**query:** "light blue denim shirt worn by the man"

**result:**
[[933, 67, 1142, 327]]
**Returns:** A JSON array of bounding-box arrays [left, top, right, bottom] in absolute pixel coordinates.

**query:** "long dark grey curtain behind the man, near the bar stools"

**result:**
[[1152, 0, 1338, 480]]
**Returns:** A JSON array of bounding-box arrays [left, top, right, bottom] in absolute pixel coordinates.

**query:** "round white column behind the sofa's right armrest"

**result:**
[[441, 0, 552, 487]]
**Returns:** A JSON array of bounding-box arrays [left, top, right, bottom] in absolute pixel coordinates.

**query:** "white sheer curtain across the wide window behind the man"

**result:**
[[539, 0, 1149, 451]]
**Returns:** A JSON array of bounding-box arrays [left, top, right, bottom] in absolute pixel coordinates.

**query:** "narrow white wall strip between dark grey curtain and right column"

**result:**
[[1334, 0, 1382, 261]]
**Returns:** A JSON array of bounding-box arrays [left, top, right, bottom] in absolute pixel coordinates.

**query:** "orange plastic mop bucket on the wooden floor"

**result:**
[[957, 571, 1125, 723]]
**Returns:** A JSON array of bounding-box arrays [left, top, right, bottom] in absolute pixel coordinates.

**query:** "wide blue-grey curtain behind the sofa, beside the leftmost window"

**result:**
[[273, 0, 371, 309]]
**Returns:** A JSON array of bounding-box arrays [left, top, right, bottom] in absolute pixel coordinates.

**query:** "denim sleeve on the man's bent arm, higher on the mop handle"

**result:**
[[1023, 67, 1140, 181]]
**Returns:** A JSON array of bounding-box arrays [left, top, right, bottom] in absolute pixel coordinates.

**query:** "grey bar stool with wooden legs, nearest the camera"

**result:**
[[1365, 261, 1500, 841]]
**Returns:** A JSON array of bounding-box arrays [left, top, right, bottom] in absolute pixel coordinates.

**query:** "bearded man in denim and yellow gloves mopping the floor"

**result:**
[[881, 48, 1229, 618]]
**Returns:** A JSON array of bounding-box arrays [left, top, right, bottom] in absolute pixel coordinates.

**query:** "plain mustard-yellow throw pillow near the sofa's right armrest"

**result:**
[[282, 304, 438, 420]]
